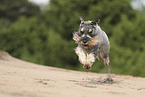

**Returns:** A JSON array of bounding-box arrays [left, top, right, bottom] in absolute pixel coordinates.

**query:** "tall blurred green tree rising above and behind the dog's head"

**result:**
[[46, 0, 135, 40]]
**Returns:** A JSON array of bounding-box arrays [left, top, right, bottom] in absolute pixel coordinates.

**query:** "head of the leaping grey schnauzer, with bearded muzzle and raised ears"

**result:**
[[73, 16, 100, 50]]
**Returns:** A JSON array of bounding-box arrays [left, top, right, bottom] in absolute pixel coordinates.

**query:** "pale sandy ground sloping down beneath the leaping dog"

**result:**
[[0, 52, 145, 97]]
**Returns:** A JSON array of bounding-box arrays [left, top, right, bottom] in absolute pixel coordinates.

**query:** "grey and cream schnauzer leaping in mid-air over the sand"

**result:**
[[73, 16, 110, 70]]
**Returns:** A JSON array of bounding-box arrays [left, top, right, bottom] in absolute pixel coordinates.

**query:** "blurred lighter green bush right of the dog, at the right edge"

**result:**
[[110, 14, 145, 76]]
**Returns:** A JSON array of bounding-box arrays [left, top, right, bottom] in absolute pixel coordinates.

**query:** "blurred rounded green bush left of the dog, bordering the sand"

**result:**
[[0, 17, 78, 69]]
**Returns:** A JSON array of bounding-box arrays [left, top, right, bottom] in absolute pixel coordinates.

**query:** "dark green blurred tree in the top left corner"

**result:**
[[0, 0, 40, 21]]
